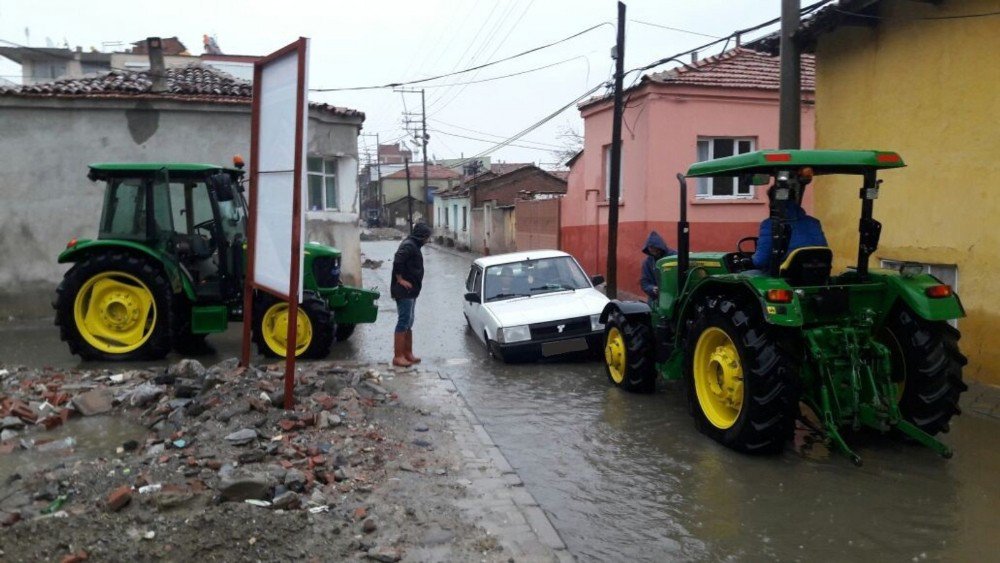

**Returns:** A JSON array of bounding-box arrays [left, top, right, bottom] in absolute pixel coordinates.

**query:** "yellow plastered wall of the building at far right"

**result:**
[[814, 0, 1000, 384]]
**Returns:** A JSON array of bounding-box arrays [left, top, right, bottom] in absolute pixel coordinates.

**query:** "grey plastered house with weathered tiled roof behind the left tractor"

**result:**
[[0, 67, 364, 316]]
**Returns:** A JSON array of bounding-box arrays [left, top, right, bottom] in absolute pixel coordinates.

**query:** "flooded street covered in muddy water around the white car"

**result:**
[[0, 242, 1000, 561]]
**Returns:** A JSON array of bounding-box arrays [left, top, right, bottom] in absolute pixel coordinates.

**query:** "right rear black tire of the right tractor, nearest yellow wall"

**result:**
[[879, 305, 968, 436]]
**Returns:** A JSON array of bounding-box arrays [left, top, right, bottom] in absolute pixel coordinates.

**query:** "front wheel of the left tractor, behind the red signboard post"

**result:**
[[253, 294, 334, 359]]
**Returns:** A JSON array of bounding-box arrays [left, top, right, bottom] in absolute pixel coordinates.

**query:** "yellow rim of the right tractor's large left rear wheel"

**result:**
[[691, 327, 743, 430]]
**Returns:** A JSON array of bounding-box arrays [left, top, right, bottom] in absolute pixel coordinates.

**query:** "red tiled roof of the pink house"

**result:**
[[643, 48, 816, 92]]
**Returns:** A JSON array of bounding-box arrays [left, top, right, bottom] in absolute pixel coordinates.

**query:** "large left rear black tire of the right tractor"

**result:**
[[684, 295, 800, 453]]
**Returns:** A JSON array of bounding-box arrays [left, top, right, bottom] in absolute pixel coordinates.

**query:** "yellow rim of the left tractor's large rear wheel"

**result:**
[[73, 272, 157, 354]]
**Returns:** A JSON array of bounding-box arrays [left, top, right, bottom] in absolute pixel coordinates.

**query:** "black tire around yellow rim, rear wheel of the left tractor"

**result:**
[[52, 250, 173, 361]]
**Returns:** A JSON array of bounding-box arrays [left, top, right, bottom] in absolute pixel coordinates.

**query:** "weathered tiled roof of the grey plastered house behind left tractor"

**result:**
[[0, 65, 365, 119]]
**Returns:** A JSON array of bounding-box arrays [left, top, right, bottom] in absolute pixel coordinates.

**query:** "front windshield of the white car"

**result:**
[[483, 256, 590, 301]]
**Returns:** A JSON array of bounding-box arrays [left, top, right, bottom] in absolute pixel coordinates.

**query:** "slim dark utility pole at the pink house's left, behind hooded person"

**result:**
[[607, 2, 625, 299]]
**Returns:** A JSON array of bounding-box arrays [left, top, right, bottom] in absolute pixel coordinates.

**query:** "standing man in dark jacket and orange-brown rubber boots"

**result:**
[[389, 223, 431, 367]]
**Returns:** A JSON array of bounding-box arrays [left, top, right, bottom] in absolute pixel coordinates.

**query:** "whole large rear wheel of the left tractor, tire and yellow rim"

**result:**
[[53, 251, 172, 361]]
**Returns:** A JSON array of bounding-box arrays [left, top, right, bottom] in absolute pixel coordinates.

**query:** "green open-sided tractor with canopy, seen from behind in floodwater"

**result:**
[[601, 150, 966, 465]]
